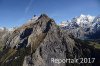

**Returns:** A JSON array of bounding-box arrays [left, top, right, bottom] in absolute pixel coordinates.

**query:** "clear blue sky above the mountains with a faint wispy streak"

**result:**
[[0, 0, 100, 27]]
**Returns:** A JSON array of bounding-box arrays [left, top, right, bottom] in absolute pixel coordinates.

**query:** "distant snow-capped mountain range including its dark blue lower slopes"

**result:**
[[59, 14, 100, 39]]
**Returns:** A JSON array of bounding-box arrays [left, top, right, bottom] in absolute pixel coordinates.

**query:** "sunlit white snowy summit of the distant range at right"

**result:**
[[60, 14, 95, 27]]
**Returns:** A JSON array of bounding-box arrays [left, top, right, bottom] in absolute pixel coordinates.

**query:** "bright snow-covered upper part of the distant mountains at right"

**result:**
[[60, 14, 95, 27]]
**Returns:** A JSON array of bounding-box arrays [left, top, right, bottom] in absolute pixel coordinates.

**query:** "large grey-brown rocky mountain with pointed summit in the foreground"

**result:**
[[0, 14, 99, 66]]
